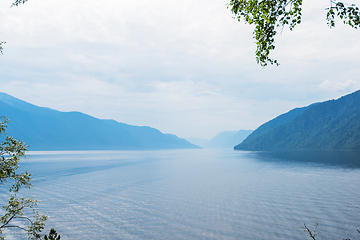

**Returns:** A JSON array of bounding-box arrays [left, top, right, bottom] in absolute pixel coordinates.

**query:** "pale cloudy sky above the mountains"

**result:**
[[0, 0, 360, 139]]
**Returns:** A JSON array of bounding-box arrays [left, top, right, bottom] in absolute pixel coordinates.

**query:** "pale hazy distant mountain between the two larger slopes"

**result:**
[[202, 130, 252, 149]]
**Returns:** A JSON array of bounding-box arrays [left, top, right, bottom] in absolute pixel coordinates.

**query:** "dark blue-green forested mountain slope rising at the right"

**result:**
[[234, 91, 360, 151]]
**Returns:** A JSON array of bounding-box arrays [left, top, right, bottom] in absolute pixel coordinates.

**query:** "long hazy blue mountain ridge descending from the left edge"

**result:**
[[0, 93, 200, 151]]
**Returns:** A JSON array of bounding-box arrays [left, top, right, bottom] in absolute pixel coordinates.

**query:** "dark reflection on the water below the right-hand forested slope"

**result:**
[[250, 150, 360, 168]]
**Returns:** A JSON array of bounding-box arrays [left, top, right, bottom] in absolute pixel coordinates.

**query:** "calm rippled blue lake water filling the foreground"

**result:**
[[0, 149, 360, 240]]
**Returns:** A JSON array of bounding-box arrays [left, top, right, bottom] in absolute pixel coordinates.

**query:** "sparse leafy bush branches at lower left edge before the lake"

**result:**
[[0, 117, 47, 239]]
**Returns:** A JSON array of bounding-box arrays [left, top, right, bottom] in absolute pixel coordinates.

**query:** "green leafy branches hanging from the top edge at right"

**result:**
[[228, 0, 360, 67]]
